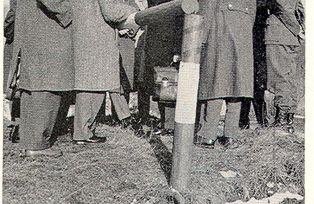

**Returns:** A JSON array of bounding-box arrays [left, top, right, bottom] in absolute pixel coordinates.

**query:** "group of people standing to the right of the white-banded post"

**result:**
[[198, 0, 305, 147]]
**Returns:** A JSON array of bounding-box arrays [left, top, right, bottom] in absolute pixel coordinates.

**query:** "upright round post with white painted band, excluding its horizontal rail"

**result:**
[[170, 14, 202, 203]]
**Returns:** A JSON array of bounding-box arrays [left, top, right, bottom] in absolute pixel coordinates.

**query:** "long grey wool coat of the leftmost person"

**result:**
[[10, 0, 74, 91]]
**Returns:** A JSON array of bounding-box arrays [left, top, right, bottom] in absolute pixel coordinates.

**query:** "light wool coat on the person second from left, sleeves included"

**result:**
[[17, 0, 137, 91]]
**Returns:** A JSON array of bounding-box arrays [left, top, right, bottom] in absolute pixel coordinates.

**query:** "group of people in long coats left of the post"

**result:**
[[3, 0, 146, 156]]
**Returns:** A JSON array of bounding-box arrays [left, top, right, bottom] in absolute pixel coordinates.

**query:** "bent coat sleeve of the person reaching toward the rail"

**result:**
[[98, 0, 138, 24]]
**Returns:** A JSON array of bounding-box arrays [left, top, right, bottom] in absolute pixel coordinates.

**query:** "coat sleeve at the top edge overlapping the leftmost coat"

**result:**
[[37, 0, 72, 27]]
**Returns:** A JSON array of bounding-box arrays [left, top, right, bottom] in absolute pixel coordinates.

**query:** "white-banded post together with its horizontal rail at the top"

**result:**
[[129, 0, 202, 204]]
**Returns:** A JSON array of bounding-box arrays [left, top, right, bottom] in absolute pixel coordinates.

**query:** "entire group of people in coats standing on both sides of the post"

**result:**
[[5, 0, 304, 156]]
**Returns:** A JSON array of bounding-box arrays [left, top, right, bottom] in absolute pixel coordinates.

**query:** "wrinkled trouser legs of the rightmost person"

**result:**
[[266, 44, 299, 133]]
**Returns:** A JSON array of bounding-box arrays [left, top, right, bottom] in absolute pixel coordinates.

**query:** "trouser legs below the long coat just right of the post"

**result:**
[[196, 99, 245, 143]]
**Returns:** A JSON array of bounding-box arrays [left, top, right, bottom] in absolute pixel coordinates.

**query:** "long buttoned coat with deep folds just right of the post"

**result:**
[[199, 0, 256, 100]]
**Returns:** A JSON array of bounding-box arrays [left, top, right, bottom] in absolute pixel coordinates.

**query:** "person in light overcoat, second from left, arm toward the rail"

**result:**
[[39, 0, 137, 144]]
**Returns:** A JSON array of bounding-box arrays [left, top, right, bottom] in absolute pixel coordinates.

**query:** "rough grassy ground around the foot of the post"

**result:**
[[3, 113, 304, 204]]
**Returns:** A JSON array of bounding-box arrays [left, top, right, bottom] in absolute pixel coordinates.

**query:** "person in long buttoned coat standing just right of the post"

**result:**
[[198, 0, 256, 145]]
